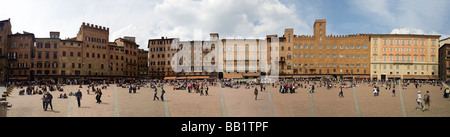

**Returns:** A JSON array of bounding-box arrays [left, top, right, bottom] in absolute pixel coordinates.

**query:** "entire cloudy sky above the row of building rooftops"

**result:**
[[0, 0, 450, 49]]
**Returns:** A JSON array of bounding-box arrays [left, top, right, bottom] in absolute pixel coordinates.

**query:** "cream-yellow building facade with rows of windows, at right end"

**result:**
[[370, 34, 440, 80]]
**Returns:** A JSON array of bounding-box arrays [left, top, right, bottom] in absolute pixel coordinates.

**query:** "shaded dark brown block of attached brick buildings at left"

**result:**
[[0, 20, 147, 82]]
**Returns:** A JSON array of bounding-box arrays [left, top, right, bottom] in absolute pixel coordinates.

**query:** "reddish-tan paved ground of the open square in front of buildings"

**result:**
[[7, 84, 450, 117]]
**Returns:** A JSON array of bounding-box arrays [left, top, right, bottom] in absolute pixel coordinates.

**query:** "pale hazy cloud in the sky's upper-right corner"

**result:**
[[348, 0, 450, 37]]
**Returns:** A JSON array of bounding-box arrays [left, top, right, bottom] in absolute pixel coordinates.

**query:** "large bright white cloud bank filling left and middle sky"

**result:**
[[0, 0, 306, 49]]
